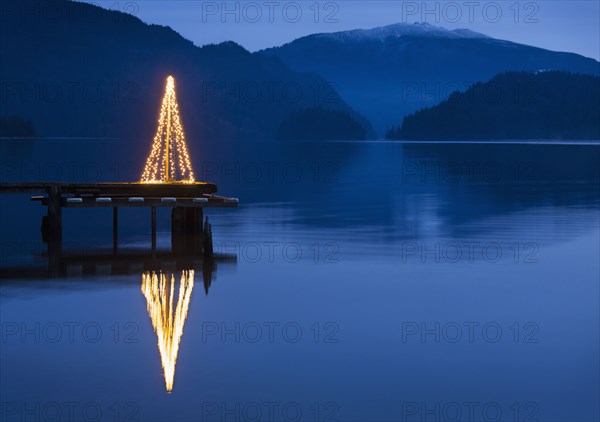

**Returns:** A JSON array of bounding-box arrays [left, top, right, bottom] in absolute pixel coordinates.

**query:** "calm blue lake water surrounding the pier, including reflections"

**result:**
[[0, 139, 600, 421]]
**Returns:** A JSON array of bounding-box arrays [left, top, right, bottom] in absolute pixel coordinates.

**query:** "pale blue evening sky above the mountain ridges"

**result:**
[[86, 0, 600, 60]]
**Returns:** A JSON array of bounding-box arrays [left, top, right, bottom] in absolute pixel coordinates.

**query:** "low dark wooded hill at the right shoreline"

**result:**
[[387, 72, 600, 141]]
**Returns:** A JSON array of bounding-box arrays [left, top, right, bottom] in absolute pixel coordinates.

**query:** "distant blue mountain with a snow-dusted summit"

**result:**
[[260, 24, 600, 135]]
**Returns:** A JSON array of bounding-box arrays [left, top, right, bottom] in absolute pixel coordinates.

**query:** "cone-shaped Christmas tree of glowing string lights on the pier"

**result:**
[[142, 76, 194, 183]]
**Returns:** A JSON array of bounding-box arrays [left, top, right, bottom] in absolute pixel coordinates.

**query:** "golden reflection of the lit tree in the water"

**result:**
[[142, 270, 194, 391]]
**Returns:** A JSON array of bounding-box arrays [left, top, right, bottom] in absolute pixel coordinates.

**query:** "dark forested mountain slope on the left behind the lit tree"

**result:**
[[0, 0, 370, 144]]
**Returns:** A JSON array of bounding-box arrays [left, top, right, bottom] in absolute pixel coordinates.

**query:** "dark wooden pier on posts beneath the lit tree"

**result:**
[[0, 182, 238, 256]]
